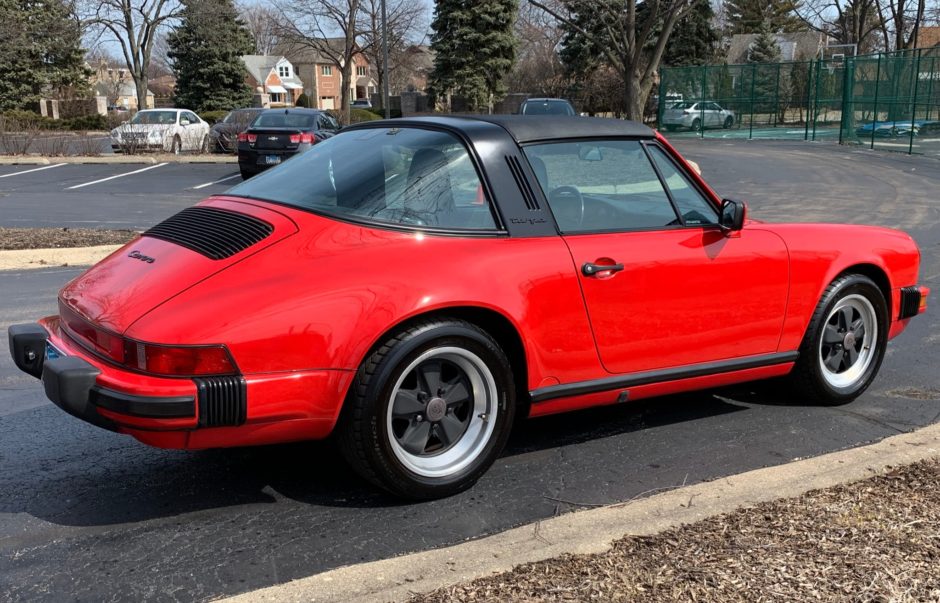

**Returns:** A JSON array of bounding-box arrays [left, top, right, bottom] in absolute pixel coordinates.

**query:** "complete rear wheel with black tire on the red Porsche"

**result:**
[[337, 318, 515, 500]]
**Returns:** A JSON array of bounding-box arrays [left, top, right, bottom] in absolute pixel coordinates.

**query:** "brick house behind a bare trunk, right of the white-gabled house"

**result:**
[[279, 38, 377, 109]]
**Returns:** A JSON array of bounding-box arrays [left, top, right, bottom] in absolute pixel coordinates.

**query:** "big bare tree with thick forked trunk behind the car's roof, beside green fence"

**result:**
[[529, 0, 692, 121]]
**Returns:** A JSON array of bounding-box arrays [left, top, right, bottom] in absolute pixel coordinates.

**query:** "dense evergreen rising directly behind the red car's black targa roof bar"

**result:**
[[428, 0, 518, 109]]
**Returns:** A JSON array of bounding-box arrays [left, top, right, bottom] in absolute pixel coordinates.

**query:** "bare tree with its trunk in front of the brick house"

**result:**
[[278, 0, 367, 123]]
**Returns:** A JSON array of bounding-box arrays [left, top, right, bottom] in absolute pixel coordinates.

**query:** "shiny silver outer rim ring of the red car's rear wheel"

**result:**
[[385, 346, 499, 478]]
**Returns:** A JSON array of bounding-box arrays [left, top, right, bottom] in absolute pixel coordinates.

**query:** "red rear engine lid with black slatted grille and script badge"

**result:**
[[59, 198, 297, 334]]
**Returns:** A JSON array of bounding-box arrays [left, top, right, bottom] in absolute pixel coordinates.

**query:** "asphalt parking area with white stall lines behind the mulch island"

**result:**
[[0, 162, 241, 230]]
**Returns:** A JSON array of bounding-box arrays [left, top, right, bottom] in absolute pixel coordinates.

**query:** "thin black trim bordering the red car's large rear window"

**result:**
[[225, 121, 510, 238]]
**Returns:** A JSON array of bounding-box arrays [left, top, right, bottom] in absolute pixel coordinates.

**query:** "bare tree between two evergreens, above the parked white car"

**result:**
[[85, 0, 180, 109]]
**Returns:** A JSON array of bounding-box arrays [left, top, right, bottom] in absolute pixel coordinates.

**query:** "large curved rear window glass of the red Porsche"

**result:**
[[228, 127, 504, 230]]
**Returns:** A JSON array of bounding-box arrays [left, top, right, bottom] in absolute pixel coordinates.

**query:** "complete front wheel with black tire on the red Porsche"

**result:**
[[789, 274, 889, 406]]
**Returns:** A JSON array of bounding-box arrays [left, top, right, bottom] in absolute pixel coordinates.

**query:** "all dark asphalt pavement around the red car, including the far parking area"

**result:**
[[0, 140, 940, 601]]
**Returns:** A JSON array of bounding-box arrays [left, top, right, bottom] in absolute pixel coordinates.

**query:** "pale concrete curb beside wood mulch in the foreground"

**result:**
[[225, 424, 940, 603]]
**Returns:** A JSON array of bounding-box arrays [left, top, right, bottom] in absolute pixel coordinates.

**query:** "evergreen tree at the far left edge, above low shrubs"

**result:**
[[0, 0, 89, 110]]
